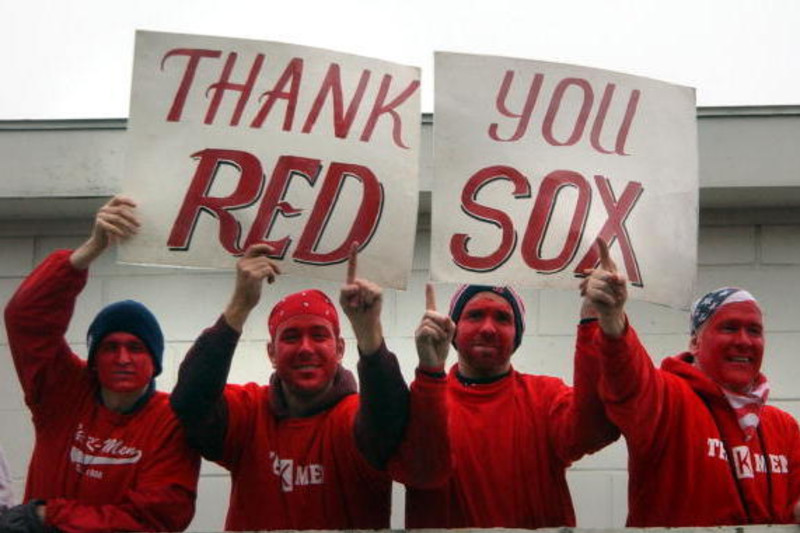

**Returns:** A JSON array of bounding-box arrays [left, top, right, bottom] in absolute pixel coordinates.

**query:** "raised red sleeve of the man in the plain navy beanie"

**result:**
[[5, 250, 88, 416]]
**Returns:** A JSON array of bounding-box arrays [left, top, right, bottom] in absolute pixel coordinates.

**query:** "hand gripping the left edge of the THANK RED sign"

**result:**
[[70, 195, 141, 269]]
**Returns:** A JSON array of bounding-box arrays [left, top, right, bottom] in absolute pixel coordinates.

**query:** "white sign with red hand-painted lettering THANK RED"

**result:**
[[120, 31, 420, 288]]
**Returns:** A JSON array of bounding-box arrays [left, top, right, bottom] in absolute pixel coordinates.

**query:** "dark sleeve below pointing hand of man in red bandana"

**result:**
[[353, 343, 409, 470]]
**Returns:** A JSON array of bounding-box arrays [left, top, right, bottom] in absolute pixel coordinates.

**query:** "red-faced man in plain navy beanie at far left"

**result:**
[[0, 197, 200, 533]]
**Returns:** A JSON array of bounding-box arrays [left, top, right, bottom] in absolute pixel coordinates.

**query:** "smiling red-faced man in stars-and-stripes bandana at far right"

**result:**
[[582, 239, 800, 527]]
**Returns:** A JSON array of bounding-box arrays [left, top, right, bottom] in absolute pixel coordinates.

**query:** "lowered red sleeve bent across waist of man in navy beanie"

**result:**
[[45, 417, 200, 533]]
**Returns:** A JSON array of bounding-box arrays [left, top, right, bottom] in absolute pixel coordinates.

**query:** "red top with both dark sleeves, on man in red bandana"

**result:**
[[172, 317, 409, 531]]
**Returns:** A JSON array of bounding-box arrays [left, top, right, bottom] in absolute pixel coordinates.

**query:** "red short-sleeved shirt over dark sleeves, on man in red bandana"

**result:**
[[220, 383, 390, 530]]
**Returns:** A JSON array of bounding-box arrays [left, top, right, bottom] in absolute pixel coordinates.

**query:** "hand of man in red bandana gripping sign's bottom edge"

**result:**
[[224, 244, 281, 331]]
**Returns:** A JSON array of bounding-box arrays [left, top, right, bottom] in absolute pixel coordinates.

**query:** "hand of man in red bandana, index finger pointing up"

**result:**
[[339, 243, 383, 355]]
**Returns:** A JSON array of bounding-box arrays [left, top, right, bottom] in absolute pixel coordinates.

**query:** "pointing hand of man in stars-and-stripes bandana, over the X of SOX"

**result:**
[[580, 238, 628, 337]]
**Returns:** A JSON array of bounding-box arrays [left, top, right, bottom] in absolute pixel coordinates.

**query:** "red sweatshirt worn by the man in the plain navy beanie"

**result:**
[[5, 251, 200, 533]]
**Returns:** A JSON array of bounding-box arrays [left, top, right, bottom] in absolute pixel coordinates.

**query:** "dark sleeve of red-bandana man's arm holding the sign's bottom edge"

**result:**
[[170, 316, 240, 461]]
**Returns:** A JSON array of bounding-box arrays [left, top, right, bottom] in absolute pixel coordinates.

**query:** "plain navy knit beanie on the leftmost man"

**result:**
[[86, 300, 164, 377]]
